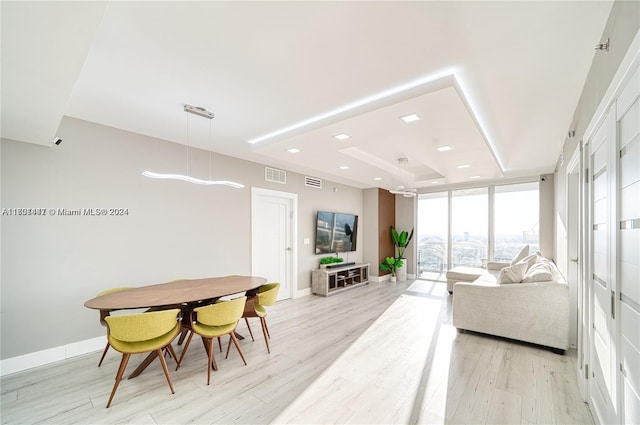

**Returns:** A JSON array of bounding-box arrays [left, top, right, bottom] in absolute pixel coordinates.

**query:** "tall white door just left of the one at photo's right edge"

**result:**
[[588, 108, 617, 424]]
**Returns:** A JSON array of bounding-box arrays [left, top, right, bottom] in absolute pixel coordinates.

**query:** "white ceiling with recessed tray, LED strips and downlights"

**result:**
[[1, 1, 612, 189]]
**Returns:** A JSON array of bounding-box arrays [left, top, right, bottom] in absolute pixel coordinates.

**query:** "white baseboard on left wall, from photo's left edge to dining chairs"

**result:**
[[0, 336, 106, 376]]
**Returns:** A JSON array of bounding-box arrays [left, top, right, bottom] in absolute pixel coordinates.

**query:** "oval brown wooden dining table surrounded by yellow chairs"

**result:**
[[84, 275, 267, 379]]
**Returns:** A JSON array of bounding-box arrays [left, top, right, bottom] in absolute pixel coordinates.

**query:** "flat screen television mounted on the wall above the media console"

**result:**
[[316, 211, 358, 254]]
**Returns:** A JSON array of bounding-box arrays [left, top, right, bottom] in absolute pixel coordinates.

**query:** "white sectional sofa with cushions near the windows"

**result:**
[[447, 247, 569, 353]]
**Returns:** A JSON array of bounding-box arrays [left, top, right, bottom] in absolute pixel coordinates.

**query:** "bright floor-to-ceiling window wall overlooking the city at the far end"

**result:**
[[417, 181, 540, 277]]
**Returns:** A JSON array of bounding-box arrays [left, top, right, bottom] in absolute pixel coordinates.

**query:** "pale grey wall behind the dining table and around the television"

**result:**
[[0, 117, 366, 359]]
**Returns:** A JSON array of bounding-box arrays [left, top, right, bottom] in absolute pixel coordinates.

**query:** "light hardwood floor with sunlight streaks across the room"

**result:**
[[0, 281, 593, 424]]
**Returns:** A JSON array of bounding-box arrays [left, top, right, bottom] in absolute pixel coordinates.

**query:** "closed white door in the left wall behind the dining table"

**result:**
[[251, 188, 297, 300]]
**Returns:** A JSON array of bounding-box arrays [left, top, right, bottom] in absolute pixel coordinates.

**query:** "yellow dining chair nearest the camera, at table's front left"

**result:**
[[105, 308, 181, 408]]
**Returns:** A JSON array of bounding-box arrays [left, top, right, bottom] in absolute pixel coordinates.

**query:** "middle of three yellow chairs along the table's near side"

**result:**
[[176, 297, 247, 385]]
